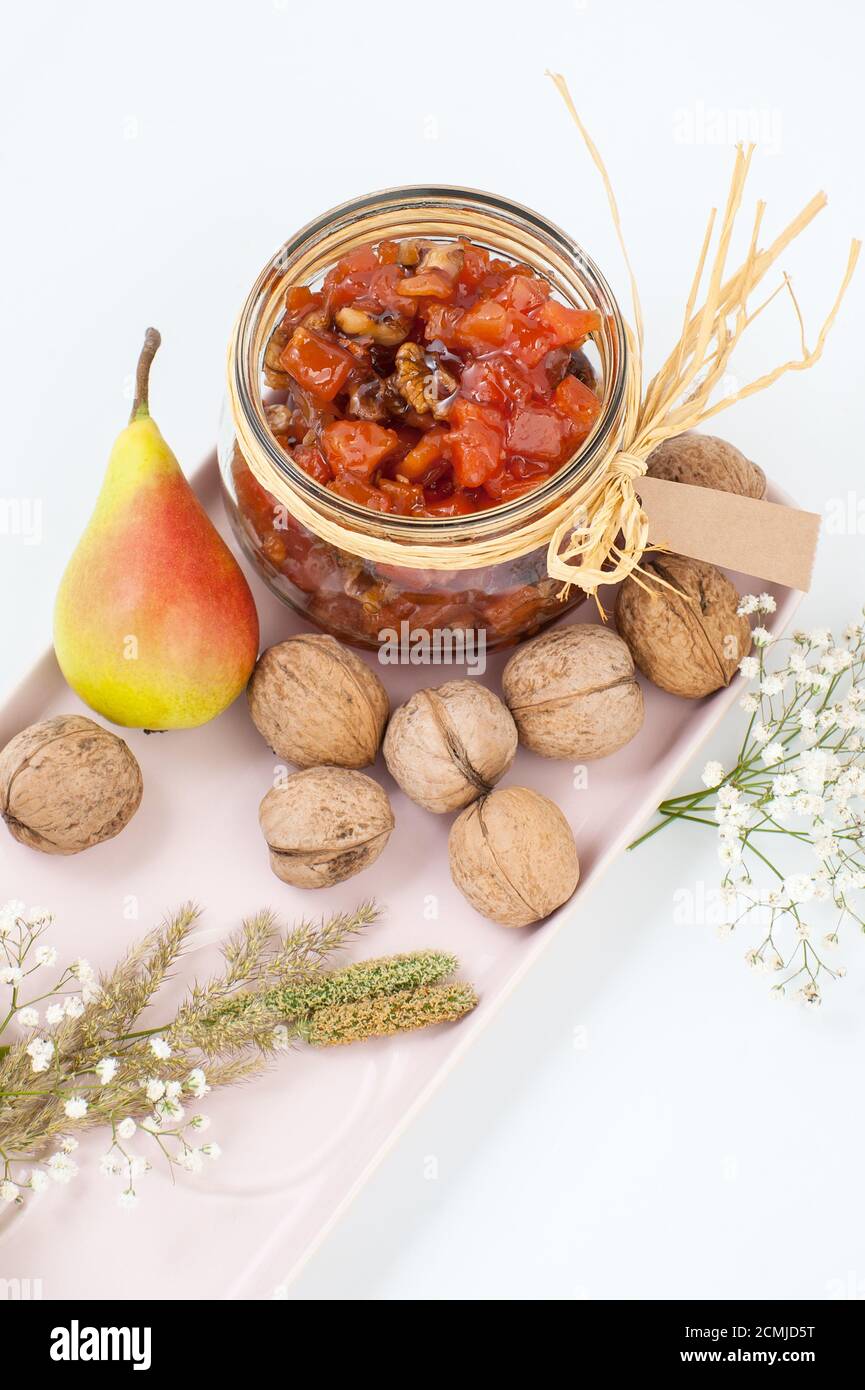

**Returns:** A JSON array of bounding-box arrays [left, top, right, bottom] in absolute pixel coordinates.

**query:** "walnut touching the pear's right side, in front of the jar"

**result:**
[[246, 632, 391, 767]]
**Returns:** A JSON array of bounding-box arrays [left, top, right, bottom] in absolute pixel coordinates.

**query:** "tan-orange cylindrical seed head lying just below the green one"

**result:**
[[302, 983, 477, 1047]]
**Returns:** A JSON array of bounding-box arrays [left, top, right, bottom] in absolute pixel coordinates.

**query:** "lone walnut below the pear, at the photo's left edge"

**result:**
[[0, 714, 143, 855]]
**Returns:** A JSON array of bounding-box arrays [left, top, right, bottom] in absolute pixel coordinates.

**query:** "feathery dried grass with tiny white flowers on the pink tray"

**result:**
[[0, 901, 378, 1207]]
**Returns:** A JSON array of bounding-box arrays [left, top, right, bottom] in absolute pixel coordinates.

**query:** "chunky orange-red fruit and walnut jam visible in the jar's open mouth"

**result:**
[[257, 239, 601, 518]]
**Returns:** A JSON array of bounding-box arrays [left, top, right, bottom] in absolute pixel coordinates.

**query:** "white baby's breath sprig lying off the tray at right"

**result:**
[[631, 594, 865, 1005]]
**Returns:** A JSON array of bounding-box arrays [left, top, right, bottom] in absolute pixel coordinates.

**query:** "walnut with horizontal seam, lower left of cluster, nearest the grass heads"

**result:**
[[259, 767, 394, 888]]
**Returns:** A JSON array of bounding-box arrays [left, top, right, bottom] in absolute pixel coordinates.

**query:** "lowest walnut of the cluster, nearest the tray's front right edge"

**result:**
[[448, 787, 580, 927]]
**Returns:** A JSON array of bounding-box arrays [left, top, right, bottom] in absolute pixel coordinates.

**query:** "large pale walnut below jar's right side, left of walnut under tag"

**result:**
[[502, 623, 644, 760]]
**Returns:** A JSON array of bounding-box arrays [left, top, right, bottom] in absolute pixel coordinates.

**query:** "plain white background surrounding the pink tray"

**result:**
[[0, 0, 865, 1298]]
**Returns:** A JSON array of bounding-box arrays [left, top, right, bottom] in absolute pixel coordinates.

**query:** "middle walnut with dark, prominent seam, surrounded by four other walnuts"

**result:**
[[384, 680, 517, 812]]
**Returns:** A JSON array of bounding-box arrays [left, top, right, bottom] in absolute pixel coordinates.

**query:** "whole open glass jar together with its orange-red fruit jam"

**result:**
[[220, 188, 627, 664]]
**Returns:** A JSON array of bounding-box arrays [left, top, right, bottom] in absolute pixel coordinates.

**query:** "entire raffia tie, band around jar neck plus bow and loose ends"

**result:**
[[228, 72, 859, 612]]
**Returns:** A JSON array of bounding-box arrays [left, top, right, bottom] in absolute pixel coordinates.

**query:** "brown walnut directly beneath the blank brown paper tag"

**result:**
[[616, 555, 751, 699]]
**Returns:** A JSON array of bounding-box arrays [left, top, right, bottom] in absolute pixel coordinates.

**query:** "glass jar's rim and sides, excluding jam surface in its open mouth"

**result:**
[[218, 188, 627, 651]]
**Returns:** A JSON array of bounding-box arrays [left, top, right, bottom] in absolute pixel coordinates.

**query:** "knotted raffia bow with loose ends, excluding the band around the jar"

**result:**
[[548, 72, 861, 594]]
